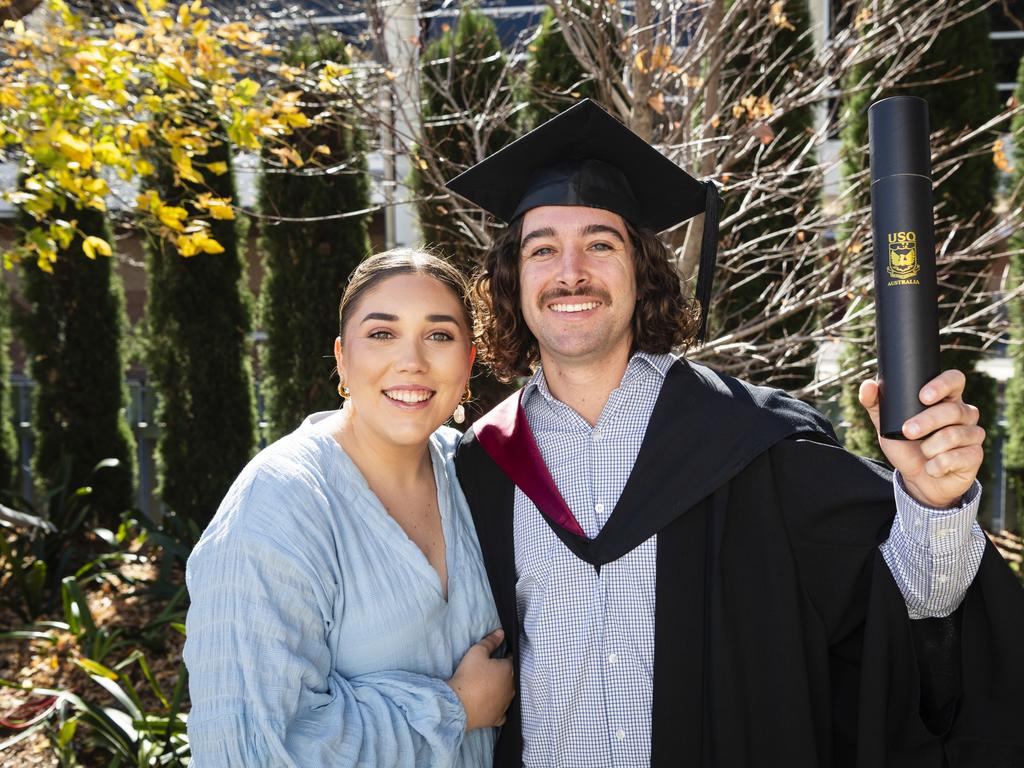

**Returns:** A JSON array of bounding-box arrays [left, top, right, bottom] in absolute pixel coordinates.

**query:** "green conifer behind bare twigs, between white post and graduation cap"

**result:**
[[411, 8, 514, 269]]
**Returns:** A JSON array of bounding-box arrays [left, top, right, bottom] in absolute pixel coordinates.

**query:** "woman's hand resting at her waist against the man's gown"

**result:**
[[447, 630, 515, 731]]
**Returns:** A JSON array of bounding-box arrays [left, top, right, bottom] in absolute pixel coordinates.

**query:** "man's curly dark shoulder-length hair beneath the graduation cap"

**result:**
[[471, 217, 700, 381]]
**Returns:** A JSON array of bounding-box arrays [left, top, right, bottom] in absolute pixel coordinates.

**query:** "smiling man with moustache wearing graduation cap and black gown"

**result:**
[[450, 101, 1024, 768]]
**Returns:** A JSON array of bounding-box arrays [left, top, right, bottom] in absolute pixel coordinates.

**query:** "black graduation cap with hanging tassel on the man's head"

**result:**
[[446, 98, 719, 341]]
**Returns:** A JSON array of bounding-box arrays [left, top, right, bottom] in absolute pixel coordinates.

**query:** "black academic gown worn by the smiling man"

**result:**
[[456, 360, 1024, 768]]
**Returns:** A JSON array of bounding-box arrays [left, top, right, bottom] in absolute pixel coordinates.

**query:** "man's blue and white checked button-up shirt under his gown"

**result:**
[[514, 352, 985, 768]]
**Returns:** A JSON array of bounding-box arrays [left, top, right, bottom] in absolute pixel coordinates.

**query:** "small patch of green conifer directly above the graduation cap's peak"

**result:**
[[520, 7, 597, 132]]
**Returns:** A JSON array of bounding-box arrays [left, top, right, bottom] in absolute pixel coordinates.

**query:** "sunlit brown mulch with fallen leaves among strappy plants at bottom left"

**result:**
[[0, 554, 188, 768]]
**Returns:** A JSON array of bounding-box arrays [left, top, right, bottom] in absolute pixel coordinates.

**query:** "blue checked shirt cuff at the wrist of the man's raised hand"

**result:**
[[893, 470, 981, 556]]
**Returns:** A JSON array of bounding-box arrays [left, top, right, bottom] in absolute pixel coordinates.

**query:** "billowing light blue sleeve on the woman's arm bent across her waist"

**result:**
[[184, 518, 466, 768]]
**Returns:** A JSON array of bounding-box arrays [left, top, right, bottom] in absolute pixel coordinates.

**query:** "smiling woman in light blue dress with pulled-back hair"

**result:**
[[184, 250, 513, 768]]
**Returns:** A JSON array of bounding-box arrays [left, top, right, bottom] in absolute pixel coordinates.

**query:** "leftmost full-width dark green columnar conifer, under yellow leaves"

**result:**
[[16, 204, 135, 524]]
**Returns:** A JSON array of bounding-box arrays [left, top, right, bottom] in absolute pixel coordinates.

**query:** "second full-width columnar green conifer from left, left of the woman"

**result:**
[[146, 132, 256, 527]]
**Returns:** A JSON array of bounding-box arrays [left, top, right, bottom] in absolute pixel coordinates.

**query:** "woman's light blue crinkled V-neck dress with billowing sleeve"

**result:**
[[184, 412, 500, 768]]
